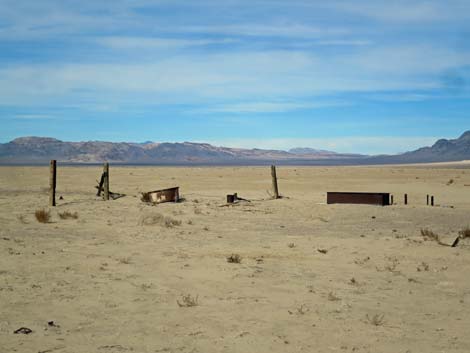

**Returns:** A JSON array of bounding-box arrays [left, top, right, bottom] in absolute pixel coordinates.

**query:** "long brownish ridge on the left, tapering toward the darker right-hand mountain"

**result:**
[[0, 136, 360, 164]]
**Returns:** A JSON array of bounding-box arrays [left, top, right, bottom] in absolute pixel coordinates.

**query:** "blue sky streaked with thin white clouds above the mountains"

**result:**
[[0, 0, 470, 153]]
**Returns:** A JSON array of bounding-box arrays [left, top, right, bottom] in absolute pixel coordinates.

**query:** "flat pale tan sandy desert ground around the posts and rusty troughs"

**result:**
[[0, 166, 470, 353]]
